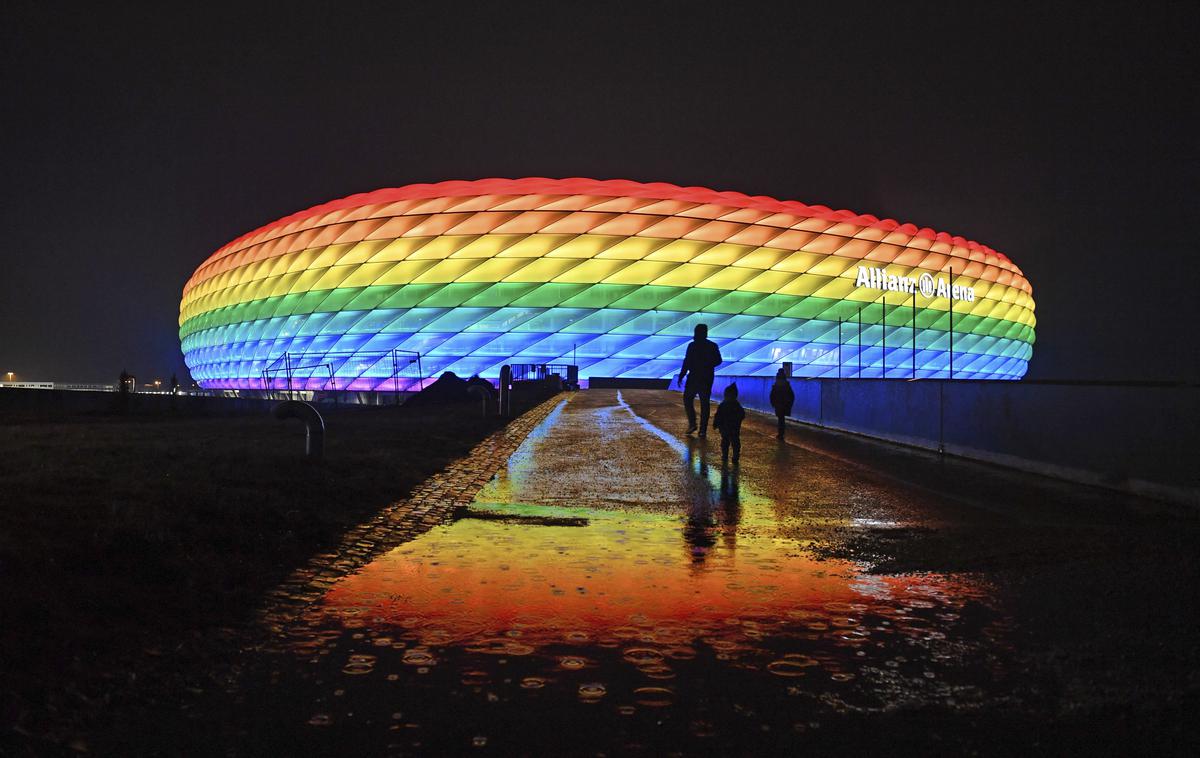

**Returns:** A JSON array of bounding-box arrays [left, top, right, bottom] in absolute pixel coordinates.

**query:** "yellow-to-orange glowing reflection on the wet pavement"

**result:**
[[323, 491, 982, 657]]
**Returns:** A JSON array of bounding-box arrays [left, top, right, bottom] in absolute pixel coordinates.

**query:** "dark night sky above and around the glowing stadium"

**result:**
[[0, 0, 1200, 381]]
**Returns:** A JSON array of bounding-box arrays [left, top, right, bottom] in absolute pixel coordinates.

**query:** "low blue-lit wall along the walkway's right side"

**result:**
[[713, 377, 1200, 505]]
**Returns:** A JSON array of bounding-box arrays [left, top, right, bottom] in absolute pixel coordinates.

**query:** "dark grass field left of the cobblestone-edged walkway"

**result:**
[[0, 403, 532, 752]]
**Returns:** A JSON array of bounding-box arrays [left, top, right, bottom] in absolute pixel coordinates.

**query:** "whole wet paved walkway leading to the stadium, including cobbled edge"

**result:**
[[220, 390, 1195, 754]]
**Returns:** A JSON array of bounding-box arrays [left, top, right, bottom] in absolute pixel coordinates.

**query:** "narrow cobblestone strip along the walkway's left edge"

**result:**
[[258, 395, 570, 638]]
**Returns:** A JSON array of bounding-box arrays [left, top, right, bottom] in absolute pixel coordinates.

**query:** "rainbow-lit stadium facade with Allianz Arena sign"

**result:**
[[180, 179, 1034, 391]]
